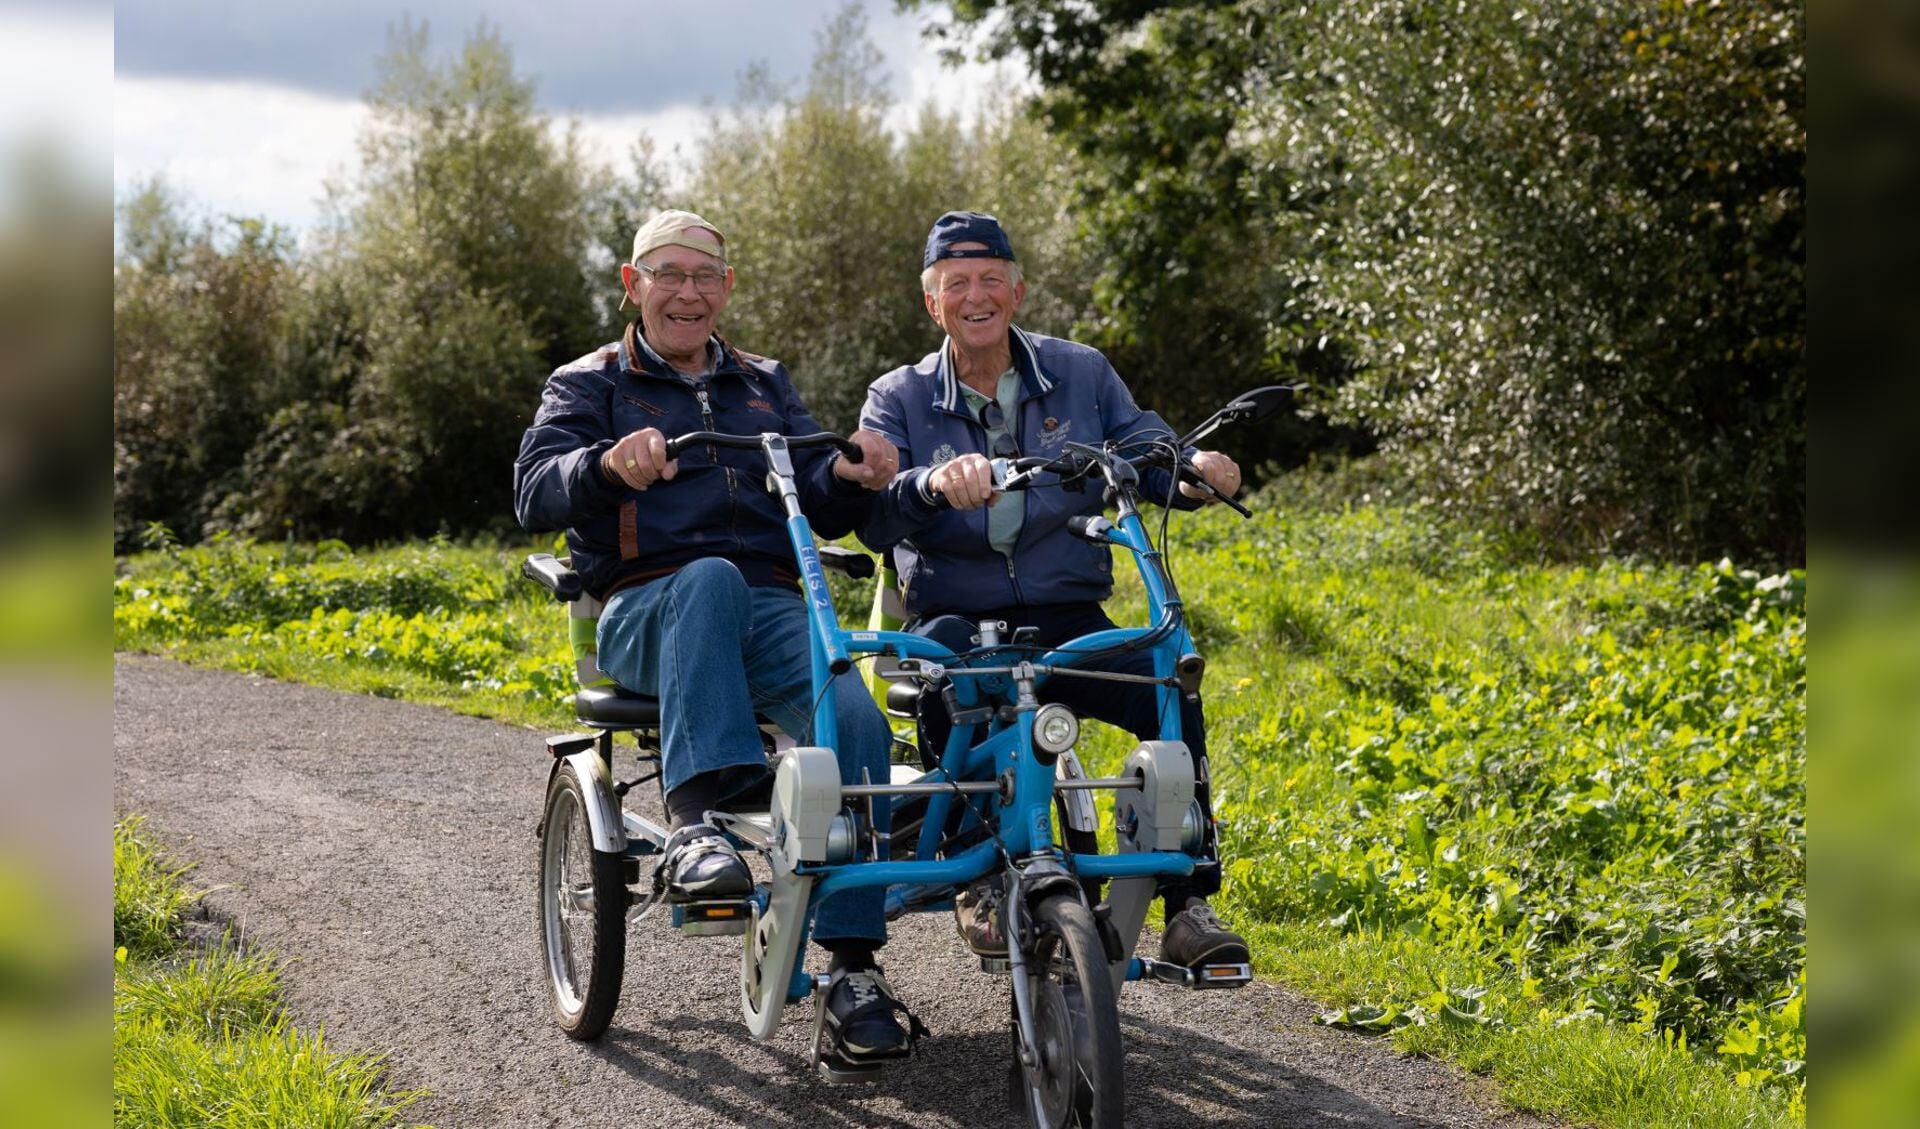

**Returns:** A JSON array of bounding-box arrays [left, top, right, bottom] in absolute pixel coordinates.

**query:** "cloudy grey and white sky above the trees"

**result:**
[[111, 0, 993, 230]]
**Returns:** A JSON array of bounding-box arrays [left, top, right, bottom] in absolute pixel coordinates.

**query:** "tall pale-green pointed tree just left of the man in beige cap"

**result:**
[[251, 23, 614, 540]]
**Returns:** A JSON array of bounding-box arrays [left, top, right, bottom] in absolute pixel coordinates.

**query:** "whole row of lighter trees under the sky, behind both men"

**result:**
[[113, 10, 1087, 551]]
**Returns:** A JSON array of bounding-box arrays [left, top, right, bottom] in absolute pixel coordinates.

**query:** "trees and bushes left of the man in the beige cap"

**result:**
[[115, 23, 632, 547]]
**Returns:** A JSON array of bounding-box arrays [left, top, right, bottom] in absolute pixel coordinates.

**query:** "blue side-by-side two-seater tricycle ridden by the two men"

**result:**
[[524, 386, 1288, 1129]]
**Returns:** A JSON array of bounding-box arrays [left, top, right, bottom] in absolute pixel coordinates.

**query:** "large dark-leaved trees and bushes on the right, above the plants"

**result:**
[[913, 0, 1805, 559]]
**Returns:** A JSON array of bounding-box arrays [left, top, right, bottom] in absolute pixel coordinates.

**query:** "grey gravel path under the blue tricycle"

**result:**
[[113, 655, 1542, 1129]]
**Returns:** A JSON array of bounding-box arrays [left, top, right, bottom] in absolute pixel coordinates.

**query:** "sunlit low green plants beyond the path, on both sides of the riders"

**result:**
[[115, 495, 1805, 1127]]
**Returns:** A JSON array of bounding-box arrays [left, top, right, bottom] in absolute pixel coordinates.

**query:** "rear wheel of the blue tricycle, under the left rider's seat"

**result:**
[[540, 764, 628, 1041]]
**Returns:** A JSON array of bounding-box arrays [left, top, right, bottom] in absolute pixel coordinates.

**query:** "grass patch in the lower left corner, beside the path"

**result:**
[[113, 816, 422, 1129]]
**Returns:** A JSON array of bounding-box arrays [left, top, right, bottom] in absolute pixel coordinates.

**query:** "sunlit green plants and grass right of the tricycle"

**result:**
[[1105, 489, 1807, 1125]]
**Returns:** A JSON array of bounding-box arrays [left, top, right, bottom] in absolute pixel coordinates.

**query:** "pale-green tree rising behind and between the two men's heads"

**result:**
[[687, 8, 1089, 430]]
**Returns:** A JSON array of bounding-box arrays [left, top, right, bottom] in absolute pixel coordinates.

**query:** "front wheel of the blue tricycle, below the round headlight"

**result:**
[[1016, 895, 1125, 1129]]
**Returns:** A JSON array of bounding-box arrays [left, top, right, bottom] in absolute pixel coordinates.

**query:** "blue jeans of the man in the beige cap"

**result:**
[[599, 557, 893, 943]]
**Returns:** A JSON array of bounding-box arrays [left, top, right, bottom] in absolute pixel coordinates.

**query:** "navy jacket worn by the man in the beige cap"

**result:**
[[513, 321, 876, 599]]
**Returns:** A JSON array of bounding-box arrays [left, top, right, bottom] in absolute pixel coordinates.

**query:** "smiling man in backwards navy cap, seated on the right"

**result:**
[[860, 211, 1248, 968]]
